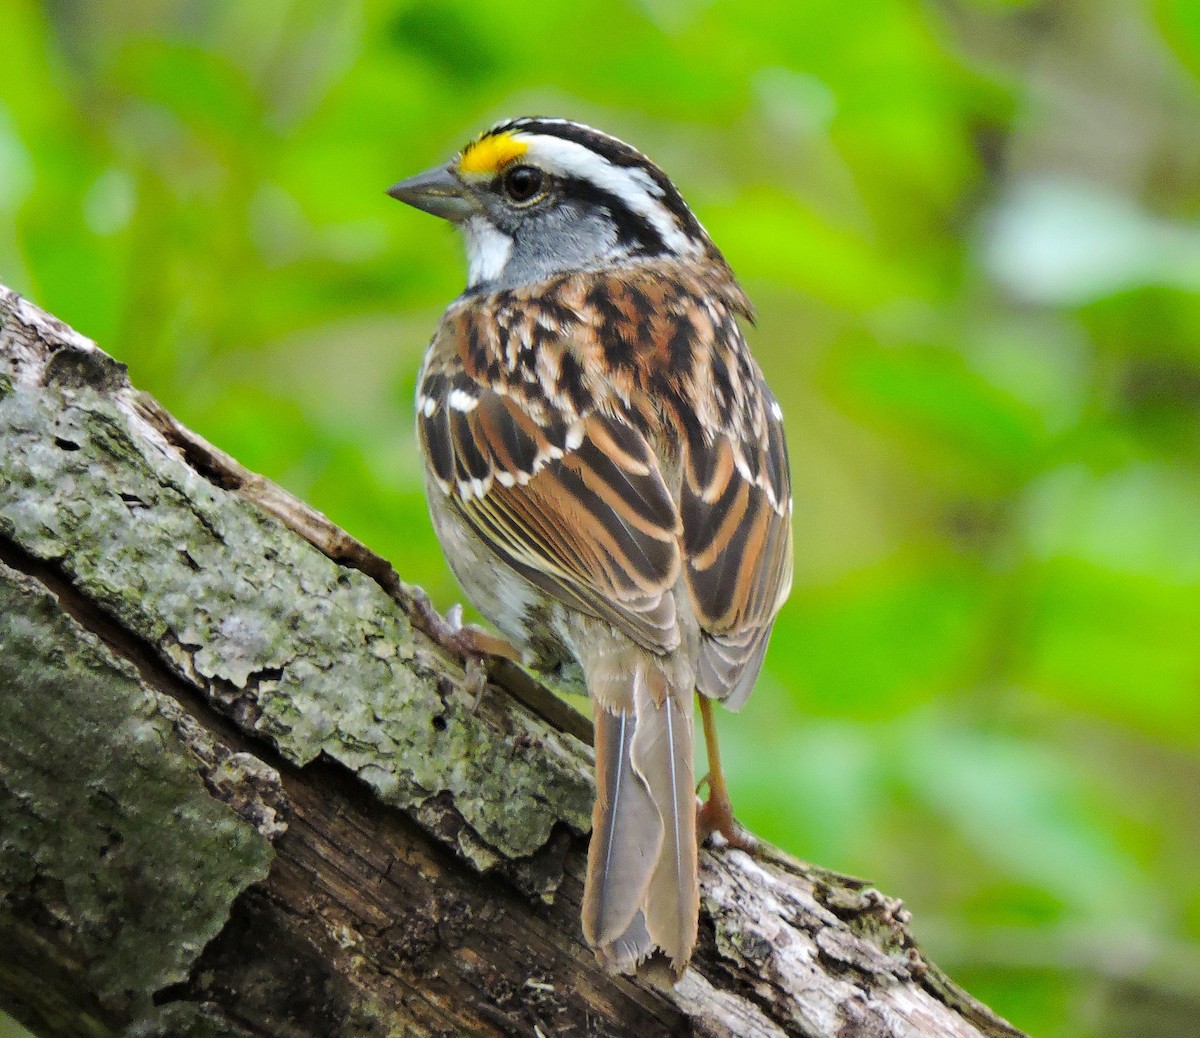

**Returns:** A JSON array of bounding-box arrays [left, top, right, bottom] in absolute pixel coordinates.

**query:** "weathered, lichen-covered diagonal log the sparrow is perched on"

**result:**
[[0, 283, 1019, 1038]]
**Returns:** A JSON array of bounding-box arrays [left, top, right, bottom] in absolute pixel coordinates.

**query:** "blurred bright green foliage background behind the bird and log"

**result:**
[[0, 0, 1200, 1038]]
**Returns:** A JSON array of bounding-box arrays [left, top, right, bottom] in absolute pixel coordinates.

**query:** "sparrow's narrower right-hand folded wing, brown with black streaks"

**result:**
[[679, 384, 792, 710]]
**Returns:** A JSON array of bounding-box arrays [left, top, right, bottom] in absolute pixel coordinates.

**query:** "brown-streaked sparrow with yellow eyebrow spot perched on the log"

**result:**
[[388, 116, 792, 979]]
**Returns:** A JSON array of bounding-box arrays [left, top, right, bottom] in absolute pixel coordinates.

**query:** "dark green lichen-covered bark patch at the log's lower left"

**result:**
[[0, 564, 272, 1020]]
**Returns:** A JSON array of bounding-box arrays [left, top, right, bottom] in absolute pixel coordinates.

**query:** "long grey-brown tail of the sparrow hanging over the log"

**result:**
[[583, 664, 700, 976]]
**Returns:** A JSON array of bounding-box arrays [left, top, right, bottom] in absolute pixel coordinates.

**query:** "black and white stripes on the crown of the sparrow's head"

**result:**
[[484, 116, 714, 256]]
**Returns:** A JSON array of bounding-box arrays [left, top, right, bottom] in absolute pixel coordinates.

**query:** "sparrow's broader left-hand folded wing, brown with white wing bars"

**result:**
[[418, 357, 682, 652]]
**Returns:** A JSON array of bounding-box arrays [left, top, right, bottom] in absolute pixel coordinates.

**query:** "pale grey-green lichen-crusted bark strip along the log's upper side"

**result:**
[[0, 367, 592, 866]]
